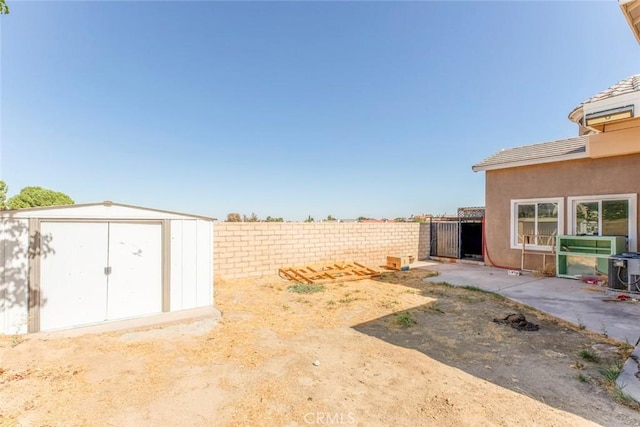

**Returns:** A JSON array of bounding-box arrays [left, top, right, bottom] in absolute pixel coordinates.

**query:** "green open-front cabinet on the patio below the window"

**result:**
[[556, 236, 627, 279]]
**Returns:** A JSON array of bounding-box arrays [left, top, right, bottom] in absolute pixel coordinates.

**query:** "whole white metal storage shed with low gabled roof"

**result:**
[[0, 202, 214, 334]]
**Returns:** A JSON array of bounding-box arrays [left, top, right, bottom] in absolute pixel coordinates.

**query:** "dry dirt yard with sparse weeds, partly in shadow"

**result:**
[[0, 270, 640, 426]]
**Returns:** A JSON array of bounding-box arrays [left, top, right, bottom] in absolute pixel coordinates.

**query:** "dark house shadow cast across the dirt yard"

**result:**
[[354, 270, 640, 426]]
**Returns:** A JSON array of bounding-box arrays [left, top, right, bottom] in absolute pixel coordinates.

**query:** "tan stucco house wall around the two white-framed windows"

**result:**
[[485, 154, 640, 269]]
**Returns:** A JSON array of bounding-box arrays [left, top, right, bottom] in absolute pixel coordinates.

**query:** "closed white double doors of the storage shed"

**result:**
[[40, 221, 162, 330]]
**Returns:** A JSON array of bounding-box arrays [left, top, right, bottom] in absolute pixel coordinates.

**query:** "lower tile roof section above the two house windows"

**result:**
[[472, 136, 588, 172]]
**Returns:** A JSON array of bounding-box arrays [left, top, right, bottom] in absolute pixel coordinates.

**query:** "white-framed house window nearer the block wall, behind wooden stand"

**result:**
[[511, 198, 563, 250]]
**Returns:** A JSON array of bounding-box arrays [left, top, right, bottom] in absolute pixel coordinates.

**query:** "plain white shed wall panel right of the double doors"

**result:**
[[171, 220, 213, 310]]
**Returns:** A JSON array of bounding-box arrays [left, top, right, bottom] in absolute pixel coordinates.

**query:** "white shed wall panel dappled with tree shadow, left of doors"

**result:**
[[0, 218, 29, 334]]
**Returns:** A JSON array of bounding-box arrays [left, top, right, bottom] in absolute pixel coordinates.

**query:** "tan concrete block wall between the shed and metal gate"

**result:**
[[213, 222, 430, 278]]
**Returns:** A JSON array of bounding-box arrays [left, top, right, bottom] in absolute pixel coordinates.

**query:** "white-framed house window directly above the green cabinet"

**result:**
[[568, 194, 637, 251]]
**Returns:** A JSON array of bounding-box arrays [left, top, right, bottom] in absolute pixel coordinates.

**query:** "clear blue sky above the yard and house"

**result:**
[[0, 0, 640, 220]]
